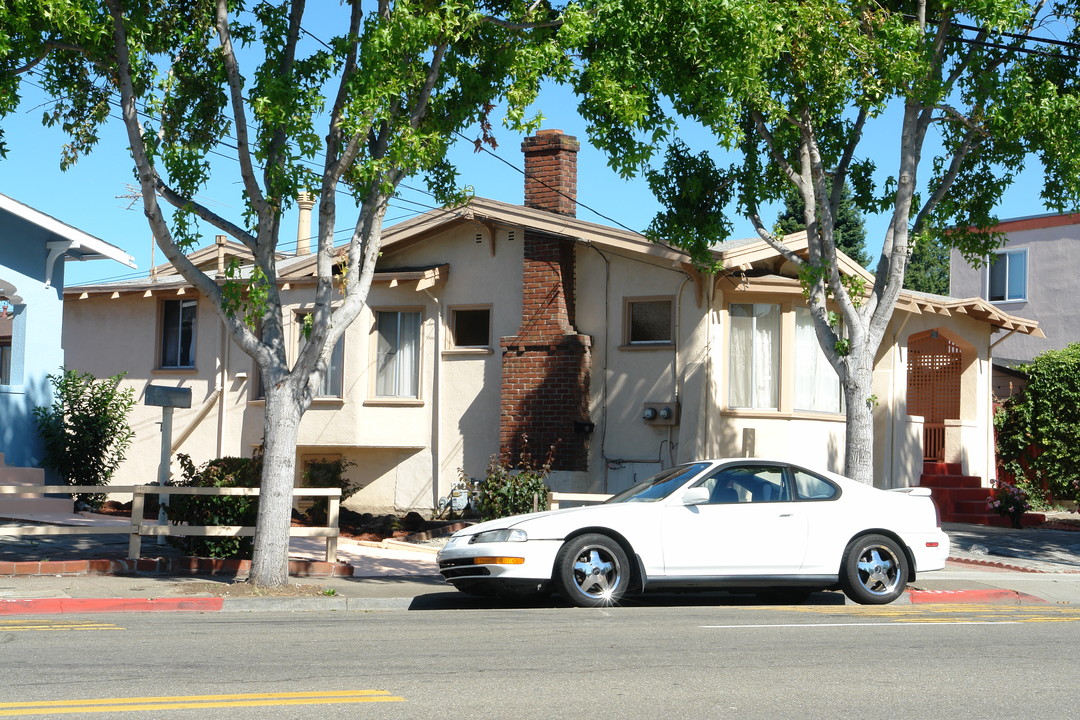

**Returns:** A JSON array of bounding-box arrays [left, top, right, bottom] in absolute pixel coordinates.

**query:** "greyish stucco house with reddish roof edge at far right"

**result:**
[[949, 214, 1080, 397]]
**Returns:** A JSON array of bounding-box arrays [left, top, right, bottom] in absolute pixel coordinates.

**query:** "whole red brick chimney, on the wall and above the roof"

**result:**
[[499, 131, 592, 471]]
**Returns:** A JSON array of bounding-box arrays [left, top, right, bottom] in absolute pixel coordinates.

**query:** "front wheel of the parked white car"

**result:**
[[555, 533, 630, 608]]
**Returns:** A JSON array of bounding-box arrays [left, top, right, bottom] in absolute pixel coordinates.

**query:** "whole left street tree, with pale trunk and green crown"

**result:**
[[0, 0, 586, 586]]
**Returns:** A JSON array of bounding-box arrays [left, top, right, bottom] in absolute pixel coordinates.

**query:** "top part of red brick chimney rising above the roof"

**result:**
[[522, 130, 581, 217]]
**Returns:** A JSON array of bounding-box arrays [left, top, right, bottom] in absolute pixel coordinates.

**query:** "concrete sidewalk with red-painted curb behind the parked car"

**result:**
[[0, 511, 1080, 614]]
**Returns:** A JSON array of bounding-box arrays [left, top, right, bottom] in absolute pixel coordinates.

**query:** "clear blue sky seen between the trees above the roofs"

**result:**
[[0, 63, 1045, 285]]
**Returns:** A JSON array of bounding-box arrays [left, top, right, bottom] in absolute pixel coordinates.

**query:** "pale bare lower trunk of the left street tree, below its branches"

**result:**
[[247, 383, 300, 587]]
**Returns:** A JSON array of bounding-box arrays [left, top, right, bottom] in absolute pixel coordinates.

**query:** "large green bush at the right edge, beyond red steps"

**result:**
[[994, 343, 1080, 510]]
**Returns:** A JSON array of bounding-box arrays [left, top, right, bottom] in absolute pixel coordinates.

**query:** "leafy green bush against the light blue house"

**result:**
[[33, 370, 135, 510]]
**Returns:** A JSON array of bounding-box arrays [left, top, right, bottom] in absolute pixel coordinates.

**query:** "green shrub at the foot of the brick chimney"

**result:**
[[473, 445, 555, 520]]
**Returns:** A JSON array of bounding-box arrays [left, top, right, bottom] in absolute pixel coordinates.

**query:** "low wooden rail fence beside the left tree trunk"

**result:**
[[0, 485, 341, 562]]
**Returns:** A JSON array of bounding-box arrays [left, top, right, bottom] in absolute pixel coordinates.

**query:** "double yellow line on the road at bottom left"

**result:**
[[0, 690, 405, 717]]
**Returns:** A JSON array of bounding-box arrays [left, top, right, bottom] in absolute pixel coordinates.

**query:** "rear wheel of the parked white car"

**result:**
[[840, 535, 908, 604]]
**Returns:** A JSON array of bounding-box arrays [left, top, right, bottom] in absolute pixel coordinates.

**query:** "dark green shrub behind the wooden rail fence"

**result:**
[[165, 452, 262, 558]]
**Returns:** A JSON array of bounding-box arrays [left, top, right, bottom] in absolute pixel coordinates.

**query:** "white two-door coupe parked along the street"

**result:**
[[438, 459, 949, 607]]
